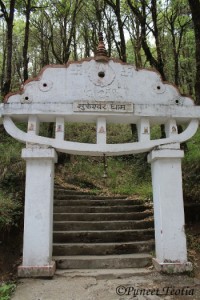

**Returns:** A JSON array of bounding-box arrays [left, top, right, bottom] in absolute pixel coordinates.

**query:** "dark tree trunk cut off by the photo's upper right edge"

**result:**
[[188, 0, 200, 105]]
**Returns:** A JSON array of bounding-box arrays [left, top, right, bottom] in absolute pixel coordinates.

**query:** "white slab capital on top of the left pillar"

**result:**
[[22, 148, 57, 163]]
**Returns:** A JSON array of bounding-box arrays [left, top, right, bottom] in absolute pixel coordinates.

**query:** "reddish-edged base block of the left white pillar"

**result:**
[[18, 261, 56, 278]]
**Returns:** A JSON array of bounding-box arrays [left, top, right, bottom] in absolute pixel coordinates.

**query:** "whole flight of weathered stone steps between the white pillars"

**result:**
[[53, 187, 154, 269]]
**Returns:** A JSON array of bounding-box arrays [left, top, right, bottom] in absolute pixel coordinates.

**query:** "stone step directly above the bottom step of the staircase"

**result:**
[[53, 240, 154, 256]]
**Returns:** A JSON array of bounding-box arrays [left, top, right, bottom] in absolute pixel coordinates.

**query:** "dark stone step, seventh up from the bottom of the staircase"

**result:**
[[54, 199, 145, 206]]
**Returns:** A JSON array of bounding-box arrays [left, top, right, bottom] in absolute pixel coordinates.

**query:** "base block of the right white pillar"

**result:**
[[152, 258, 193, 274]]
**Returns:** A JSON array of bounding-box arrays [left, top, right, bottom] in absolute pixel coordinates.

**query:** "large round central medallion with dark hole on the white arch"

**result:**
[[88, 63, 116, 87]]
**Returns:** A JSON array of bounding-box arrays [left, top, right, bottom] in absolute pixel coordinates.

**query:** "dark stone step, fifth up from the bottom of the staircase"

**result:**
[[54, 210, 152, 222]]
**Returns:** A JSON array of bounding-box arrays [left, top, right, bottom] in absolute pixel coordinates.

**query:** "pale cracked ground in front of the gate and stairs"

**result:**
[[12, 270, 200, 300]]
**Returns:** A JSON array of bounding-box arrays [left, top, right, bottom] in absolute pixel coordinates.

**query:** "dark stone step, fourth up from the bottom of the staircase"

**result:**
[[54, 220, 154, 231]]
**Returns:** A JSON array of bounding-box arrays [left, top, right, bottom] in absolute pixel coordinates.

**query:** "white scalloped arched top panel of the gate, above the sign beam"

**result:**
[[3, 59, 193, 106]]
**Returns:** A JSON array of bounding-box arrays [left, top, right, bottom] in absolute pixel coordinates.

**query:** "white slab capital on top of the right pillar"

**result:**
[[148, 149, 184, 163]]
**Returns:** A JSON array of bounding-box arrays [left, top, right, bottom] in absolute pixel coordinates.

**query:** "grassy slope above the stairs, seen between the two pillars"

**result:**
[[56, 155, 152, 199]]
